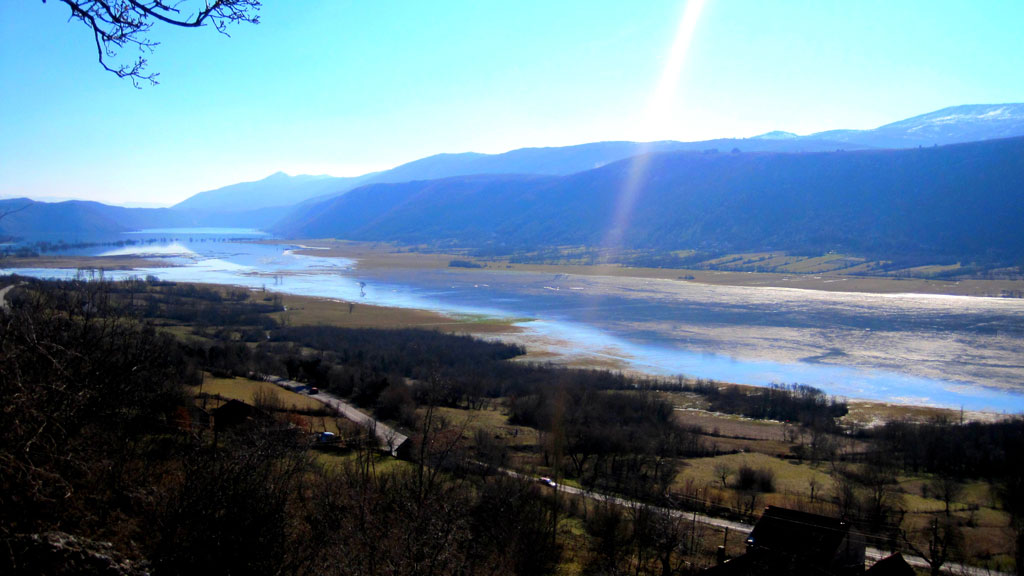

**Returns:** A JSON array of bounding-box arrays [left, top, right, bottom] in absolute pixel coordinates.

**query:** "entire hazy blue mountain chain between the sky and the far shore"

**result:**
[[6, 104, 1024, 263]]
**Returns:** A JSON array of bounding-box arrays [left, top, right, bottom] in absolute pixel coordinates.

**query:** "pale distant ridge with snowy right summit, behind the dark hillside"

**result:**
[[163, 104, 1024, 220]]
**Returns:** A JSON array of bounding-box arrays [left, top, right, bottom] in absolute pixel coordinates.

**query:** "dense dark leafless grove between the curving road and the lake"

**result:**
[[207, 327, 707, 496]]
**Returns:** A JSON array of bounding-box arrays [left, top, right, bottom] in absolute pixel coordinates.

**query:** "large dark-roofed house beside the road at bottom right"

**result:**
[[705, 506, 865, 576]]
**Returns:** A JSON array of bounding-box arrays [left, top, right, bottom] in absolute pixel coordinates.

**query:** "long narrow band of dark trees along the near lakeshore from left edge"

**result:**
[[4, 277, 847, 427]]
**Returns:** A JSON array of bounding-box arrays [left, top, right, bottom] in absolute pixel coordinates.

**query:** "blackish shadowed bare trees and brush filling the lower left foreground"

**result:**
[[0, 276, 560, 576]]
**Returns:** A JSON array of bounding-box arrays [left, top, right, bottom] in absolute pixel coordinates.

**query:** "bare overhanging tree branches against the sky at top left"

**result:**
[[50, 0, 260, 88]]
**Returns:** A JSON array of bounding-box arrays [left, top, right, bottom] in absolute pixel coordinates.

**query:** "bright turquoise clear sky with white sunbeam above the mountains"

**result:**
[[0, 0, 1024, 205]]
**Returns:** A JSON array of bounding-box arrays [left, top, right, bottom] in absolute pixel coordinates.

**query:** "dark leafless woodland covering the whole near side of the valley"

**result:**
[[0, 280, 1024, 576]]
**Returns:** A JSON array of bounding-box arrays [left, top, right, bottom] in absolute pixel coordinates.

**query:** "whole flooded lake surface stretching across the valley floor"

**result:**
[[2, 229, 1024, 413]]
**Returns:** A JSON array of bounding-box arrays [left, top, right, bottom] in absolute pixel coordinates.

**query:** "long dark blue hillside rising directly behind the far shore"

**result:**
[[276, 138, 1024, 263]]
